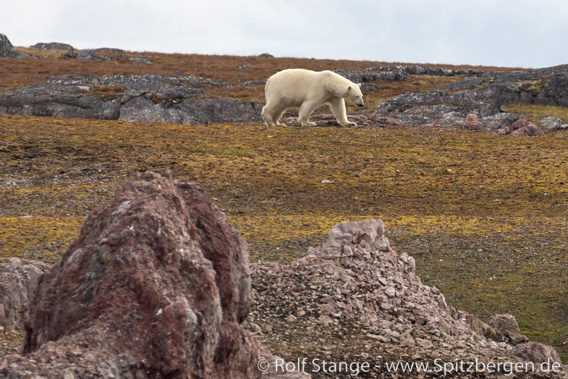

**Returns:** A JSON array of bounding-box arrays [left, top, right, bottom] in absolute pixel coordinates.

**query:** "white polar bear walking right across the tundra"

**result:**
[[262, 68, 364, 126]]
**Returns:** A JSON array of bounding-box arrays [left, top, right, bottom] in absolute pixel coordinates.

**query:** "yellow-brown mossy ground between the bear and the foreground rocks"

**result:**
[[0, 116, 568, 358]]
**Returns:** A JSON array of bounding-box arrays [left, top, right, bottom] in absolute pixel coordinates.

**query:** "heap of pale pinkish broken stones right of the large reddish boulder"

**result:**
[[246, 220, 565, 378]]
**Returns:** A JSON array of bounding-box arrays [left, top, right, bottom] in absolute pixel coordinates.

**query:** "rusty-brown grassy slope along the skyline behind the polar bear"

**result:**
[[4, 48, 524, 88]]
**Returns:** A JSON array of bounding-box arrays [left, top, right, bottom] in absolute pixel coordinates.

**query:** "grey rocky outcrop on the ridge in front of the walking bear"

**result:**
[[372, 65, 568, 131]]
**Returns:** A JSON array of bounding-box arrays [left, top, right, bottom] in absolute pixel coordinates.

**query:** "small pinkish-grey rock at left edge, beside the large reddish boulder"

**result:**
[[0, 258, 50, 331]]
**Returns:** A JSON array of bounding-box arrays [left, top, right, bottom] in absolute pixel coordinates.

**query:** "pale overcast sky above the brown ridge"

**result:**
[[0, 0, 568, 68]]
